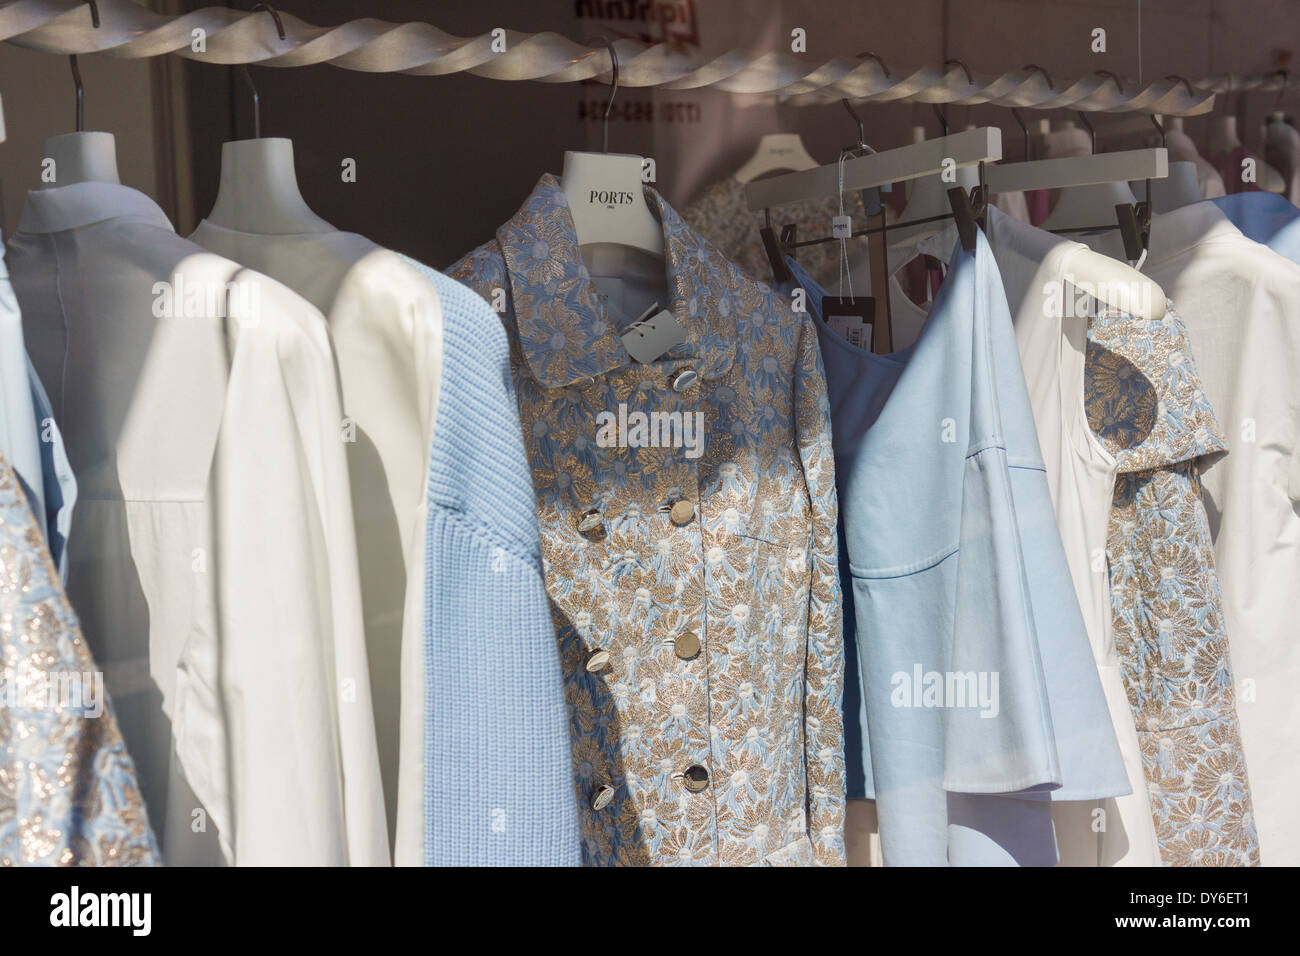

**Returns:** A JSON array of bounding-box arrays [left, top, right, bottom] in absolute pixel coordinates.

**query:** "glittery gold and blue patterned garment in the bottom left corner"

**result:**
[[0, 458, 160, 866]]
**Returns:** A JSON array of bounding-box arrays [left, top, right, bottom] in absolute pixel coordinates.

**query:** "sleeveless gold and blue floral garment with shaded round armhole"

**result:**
[[1086, 306, 1260, 866]]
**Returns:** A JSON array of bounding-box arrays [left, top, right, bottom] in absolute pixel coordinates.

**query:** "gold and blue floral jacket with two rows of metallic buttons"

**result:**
[[450, 176, 844, 865]]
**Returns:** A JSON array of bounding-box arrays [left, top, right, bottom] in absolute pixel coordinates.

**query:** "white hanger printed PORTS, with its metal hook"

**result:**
[[560, 43, 664, 258]]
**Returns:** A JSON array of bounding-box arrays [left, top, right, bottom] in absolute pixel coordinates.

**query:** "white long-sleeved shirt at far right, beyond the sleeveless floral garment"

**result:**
[[1089, 202, 1300, 866]]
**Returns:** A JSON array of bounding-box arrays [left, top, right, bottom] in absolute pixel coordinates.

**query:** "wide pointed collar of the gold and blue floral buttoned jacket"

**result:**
[[497, 173, 743, 388]]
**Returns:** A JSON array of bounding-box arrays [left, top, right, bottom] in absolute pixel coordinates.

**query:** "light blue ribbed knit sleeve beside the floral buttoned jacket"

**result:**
[[403, 256, 581, 866]]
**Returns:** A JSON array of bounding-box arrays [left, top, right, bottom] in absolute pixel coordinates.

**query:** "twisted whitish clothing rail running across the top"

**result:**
[[0, 0, 1216, 116]]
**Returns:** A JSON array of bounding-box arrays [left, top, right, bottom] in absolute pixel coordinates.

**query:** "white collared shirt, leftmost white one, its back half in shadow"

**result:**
[[10, 182, 389, 865]]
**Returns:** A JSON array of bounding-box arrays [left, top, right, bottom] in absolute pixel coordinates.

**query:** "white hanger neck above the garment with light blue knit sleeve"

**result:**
[[207, 137, 337, 235]]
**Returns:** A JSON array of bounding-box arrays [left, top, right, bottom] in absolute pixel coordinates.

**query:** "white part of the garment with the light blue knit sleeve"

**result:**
[[190, 220, 442, 864]]
